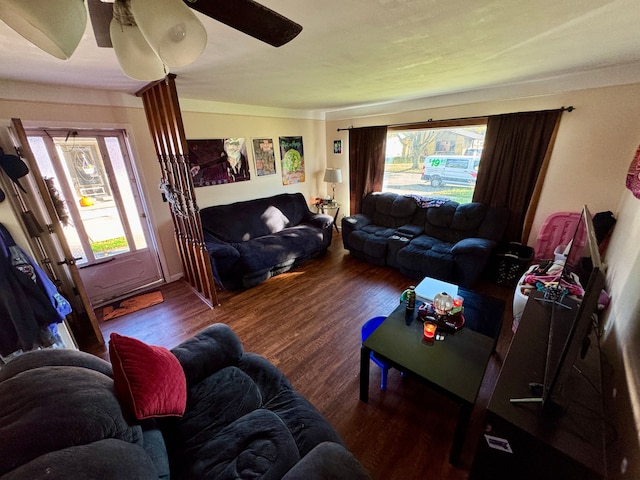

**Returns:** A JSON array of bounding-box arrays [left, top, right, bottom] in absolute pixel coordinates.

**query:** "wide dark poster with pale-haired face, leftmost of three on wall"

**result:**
[[187, 138, 251, 187]]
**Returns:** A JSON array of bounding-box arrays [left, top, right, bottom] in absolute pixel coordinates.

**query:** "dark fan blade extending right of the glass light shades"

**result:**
[[184, 0, 302, 47]]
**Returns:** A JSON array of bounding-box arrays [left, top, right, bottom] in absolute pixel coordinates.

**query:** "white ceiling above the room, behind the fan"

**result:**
[[0, 0, 640, 112]]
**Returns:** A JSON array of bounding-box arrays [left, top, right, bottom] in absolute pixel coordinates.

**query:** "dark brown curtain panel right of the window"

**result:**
[[473, 109, 562, 241]]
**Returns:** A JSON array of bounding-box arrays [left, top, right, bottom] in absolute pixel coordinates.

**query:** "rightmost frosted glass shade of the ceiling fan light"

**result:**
[[131, 0, 207, 67]]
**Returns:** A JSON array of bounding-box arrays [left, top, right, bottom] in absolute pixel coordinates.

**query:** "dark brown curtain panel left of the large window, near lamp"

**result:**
[[349, 126, 387, 215]]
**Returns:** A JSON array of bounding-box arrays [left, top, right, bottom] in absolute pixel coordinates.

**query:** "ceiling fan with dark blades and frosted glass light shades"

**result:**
[[0, 0, 302, 81]]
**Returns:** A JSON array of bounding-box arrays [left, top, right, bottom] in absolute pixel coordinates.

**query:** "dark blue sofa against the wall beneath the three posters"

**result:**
[[200, 193, 333, 290]]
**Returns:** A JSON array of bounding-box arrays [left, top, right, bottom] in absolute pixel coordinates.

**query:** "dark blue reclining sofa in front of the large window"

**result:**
[[342, 192, 508, 287]]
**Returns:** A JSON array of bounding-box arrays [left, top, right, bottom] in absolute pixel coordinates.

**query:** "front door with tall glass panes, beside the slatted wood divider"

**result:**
[[26, 129, 163, 306]]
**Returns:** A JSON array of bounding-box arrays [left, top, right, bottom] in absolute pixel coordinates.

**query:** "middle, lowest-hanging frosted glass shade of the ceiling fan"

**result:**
[[109, 18, 165, 82]]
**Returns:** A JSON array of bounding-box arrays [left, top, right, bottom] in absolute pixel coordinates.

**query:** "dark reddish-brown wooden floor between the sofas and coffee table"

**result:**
[[90, 235, 512, 480]]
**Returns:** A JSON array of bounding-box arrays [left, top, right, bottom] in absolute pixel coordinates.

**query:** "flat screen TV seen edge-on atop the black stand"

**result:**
[[542, 205, 605, 411]]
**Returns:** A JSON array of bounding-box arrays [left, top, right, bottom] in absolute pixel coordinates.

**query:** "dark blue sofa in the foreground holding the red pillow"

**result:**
[[0, 324, 370, 480]]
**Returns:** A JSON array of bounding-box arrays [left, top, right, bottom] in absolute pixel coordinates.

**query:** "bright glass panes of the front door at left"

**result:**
[[28, 132, 147, 265]]
